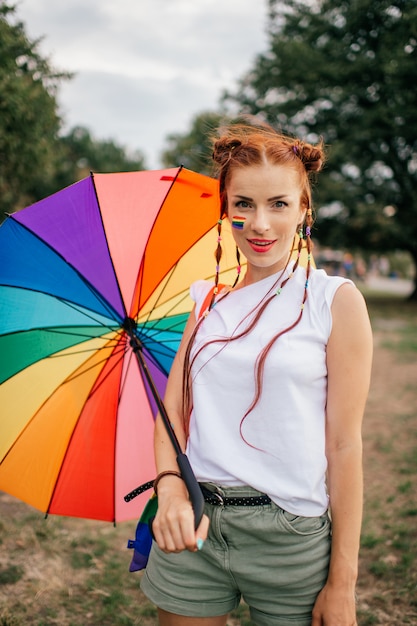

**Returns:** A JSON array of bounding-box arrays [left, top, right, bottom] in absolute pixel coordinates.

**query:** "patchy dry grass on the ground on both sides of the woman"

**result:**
[[0, 296, 417, 626]]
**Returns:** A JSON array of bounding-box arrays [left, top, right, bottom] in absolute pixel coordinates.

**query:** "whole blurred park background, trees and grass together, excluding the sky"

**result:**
[[0, 0, 417, 626]]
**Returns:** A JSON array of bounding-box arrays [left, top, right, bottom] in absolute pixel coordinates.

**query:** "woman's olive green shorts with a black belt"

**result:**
[[141, 485, 331, 626]]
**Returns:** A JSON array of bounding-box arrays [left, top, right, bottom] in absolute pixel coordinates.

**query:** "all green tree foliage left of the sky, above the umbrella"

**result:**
[[0, 0, 145, 222]]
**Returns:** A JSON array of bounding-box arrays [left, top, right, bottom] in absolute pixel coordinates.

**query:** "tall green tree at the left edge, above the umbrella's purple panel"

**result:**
[[0, 0, 69, 221]]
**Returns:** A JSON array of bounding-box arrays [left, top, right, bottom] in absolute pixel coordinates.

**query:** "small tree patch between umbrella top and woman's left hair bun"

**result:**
[[162, 112, 224, 175]]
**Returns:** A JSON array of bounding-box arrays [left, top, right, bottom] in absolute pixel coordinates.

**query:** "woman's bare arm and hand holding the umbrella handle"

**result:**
[[152, 311, 208, 552]]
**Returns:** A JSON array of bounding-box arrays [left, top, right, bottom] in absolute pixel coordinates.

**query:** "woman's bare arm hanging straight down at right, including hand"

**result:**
[[312, 284, 372, 626]]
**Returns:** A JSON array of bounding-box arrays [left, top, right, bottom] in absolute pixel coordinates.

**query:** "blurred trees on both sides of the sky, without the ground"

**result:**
[[0, 0, 417, 298]]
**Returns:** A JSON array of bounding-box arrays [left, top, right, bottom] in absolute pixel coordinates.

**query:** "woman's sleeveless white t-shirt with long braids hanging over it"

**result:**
[[187, 267, 350, 516]]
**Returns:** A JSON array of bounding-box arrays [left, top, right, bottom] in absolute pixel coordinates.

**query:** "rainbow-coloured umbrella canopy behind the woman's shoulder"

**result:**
[[0, 168, 310, 522]]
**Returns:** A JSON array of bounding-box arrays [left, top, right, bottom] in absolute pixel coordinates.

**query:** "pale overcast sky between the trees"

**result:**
[[17, 0, 267, 168]]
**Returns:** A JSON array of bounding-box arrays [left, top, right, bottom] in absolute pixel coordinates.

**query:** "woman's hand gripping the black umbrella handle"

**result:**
[[152, 476, 209, 553]]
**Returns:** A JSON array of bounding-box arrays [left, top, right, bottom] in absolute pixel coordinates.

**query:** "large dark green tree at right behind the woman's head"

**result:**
[[225, 0, 417, 298]]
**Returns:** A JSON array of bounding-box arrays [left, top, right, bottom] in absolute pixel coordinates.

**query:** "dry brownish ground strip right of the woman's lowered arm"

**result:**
[[358, 320, 417, 626]]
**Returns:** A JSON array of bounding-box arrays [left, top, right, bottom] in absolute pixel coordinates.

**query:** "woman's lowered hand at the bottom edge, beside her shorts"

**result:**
[[311, 583, 358, 626]]
